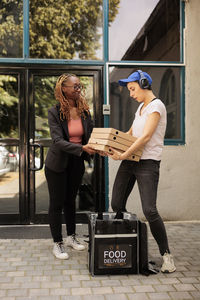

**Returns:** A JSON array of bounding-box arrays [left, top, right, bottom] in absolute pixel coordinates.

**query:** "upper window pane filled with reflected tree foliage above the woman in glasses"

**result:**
[[30, 0, 103, 60]]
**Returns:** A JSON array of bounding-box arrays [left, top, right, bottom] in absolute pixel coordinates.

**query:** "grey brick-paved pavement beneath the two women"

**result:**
[[0, 222, 200, 300]]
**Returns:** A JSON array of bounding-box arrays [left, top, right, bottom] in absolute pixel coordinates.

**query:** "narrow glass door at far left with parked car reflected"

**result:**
[[0, 68, 28, 224]]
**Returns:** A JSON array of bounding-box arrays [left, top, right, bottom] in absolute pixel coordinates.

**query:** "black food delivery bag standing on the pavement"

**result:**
[[88, 212, 148, 276]]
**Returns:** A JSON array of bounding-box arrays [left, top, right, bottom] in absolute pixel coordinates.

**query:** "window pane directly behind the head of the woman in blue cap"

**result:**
[[110, 66, 181, 139]]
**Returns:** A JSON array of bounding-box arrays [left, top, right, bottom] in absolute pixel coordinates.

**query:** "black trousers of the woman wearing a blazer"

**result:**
[[45, 155, 85, 242]]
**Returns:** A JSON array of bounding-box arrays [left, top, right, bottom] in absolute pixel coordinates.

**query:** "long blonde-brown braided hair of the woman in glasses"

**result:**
[[54, 73, 89, 121]]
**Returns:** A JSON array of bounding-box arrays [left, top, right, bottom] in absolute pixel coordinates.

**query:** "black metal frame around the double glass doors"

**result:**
[[0, 64, 105, 224]]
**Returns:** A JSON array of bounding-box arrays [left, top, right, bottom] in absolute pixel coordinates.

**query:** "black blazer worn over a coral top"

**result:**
[[45, 104, 93, 172]]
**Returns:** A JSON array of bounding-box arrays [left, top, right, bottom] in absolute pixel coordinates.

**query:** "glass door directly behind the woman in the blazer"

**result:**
[[29, 68, 105, 223]]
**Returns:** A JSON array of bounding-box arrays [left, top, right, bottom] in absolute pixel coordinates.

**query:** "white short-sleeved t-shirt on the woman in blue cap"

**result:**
[[132, 99, 167, 160]]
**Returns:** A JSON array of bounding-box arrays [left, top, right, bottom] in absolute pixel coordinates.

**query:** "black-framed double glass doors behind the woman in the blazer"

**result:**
[[0, 65, 105, 224]]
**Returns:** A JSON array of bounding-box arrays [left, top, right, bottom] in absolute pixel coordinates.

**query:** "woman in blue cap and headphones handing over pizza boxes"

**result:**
[[109, 70, 176, 273]]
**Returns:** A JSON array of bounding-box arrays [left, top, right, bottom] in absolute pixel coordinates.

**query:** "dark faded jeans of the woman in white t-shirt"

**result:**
[[111, 159, 170, 255]]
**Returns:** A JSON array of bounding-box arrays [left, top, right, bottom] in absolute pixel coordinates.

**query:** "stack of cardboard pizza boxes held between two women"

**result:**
[[89, 128, 142, 161]]
